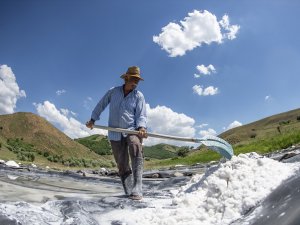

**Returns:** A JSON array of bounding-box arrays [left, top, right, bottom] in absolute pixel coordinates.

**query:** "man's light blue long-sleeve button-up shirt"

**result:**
[[91, 86, 147, 141]]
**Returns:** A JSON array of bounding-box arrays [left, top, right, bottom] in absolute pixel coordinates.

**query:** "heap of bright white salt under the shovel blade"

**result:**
[[97, 153, 299, 225]]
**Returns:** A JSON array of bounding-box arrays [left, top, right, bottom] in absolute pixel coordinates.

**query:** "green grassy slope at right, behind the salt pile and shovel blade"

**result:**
[[146, 109, 300, 168]]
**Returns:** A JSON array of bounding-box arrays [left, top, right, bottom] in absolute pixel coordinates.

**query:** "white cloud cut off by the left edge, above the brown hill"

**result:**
[[0, 65, 26, 114]]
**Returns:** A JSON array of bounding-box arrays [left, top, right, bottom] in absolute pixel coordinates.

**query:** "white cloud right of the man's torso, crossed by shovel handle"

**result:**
[[144, 104, 195, 146]]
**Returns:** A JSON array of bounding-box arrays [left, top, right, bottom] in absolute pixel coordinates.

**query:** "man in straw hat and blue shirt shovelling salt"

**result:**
[[86, 66, 147, 200]]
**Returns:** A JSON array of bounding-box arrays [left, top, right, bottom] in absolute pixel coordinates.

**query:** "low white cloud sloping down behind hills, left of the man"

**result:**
[[33, 101, 107, 138]]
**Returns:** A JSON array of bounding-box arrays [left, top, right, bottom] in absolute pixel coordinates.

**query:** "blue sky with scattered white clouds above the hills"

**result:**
[[0, 0, 300, 144]]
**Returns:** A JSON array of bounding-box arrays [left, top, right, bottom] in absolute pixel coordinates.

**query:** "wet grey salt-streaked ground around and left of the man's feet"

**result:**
[[0, 166, 189, 225]]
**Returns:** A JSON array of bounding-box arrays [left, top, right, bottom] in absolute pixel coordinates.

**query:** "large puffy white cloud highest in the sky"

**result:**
[[153, 10, 240, 57]]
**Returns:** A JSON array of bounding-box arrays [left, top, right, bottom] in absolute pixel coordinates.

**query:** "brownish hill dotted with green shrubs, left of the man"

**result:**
[[0, 112, 112, 167]]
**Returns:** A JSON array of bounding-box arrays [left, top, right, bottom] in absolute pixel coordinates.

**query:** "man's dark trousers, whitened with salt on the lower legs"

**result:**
[[110, 135, 143, 196]]
